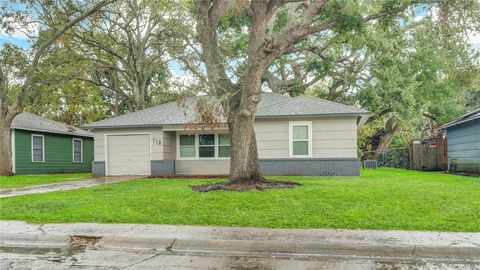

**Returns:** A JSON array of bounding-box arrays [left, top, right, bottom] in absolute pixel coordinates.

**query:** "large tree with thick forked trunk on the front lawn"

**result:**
[[187, 0, 472, 191]]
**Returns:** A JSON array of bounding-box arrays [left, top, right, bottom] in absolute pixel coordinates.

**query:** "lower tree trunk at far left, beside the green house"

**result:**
[[0, 115, 13, 175]]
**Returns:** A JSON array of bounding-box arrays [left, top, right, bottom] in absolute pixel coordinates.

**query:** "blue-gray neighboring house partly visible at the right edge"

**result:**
[[440, 109, 480, 173]]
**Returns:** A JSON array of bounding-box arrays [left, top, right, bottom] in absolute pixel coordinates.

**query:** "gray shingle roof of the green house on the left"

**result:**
[[12, 112, 93, 137]]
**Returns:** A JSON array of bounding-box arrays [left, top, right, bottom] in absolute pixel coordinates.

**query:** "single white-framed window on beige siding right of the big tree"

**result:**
[[290, 122, 312, 157]]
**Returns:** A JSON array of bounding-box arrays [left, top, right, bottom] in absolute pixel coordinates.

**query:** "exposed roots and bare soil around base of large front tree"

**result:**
[[192, 180, 303, 192]]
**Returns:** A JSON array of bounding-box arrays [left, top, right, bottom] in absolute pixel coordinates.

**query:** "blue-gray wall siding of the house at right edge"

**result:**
[[447, 119, 480, 173]]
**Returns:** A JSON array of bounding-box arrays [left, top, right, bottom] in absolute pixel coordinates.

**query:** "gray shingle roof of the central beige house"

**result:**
[[82, 93, 368, 128]]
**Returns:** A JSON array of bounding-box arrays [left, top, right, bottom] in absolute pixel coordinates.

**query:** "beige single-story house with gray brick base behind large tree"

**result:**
[[82, 93, 369, 176]]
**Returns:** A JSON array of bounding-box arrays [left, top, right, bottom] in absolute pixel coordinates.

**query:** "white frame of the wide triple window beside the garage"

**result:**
[[176, 131, 230, 160]]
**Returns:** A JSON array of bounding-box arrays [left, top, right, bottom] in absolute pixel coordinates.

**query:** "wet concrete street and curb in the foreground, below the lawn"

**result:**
[[0, 221, 480, 270]]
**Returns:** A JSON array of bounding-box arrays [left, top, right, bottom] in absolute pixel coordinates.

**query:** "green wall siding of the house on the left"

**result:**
[[15, 129, 93, 174]]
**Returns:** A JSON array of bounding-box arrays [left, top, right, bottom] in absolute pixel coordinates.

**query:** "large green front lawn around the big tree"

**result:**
[[0, 169, 480, 232]]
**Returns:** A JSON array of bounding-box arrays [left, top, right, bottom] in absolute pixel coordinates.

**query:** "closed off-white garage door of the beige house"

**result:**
[[107, 134, 150, 175]]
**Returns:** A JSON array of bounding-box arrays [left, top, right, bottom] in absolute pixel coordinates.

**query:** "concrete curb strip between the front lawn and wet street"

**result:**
[[0, 221, 480, 264]]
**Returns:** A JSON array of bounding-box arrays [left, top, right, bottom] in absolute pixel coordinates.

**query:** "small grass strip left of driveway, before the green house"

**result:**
[[0, 173, 92, 189]]
